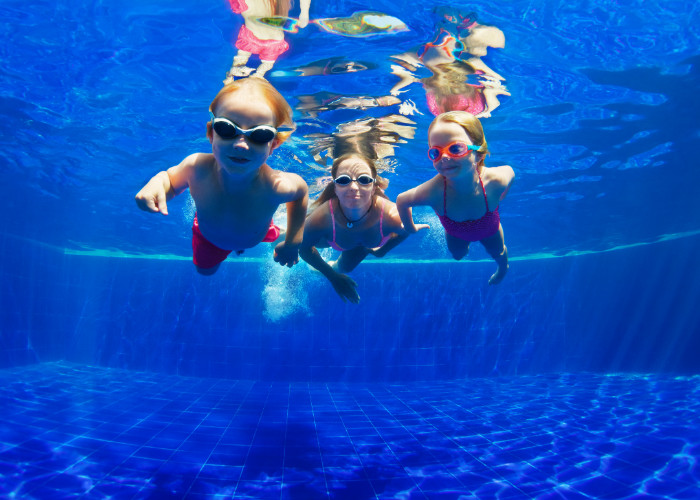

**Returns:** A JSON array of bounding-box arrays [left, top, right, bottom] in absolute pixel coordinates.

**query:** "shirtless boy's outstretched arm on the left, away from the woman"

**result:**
[[136, 154, 198, 215]]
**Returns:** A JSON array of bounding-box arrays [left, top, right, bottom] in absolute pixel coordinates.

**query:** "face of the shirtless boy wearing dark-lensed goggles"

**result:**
[[209, 89, 279, 175]]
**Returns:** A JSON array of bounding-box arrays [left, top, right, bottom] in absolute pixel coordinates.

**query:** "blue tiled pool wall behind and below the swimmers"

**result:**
[[0, 236, 700, 382]]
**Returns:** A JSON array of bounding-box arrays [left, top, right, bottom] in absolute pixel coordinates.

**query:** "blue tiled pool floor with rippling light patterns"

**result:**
[[0, 363, 700, 500]]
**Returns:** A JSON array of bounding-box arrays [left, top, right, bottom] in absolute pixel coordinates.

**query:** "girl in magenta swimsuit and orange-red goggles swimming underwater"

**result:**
[[396, 111, 515, 285]]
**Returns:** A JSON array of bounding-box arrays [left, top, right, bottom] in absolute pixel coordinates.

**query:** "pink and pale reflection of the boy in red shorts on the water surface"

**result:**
[[224, 0, 311, 83]]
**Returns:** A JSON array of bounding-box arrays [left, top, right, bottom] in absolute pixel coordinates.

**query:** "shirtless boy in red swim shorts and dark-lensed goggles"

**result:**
[[136, 78, 308, 274]]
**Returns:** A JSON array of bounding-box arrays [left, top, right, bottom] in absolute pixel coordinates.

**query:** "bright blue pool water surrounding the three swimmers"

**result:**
[[0, 0, 700, 499]]
